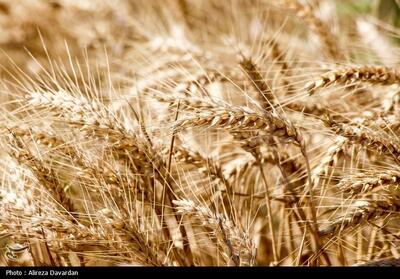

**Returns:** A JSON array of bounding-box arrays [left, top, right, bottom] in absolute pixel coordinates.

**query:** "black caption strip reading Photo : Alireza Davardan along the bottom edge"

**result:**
[[0, 267, 400, 279]]
